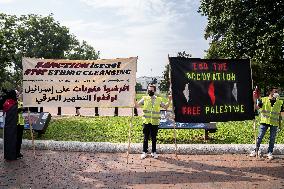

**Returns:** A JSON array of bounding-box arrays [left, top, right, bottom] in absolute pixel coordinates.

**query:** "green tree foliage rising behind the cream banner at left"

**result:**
[[0, 14, 99, 90]]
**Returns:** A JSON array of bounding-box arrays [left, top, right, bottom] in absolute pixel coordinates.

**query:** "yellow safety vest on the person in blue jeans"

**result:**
[[260, 97, 283, 126]]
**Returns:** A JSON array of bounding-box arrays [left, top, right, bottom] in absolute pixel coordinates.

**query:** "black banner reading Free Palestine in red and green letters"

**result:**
[[169, 57, 254, 123]]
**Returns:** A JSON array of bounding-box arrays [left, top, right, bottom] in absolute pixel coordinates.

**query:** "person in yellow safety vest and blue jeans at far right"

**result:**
[[250, 87, 284, 160]]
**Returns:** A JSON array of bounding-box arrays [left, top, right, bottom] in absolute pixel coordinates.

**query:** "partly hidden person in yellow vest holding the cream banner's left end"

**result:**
[[16, 92, 25, 159]]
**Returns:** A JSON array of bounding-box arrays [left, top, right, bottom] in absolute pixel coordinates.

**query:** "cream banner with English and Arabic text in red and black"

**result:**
[[22, 57, 137, 107]]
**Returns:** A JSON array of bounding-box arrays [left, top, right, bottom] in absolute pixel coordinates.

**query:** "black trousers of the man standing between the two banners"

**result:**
[[143, 123, 158, 153]]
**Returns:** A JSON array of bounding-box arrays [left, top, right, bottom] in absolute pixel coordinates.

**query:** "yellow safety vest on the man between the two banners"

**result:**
[[143, 96, 162, 125]]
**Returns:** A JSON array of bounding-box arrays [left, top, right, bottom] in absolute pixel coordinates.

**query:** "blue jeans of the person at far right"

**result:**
[[256, 123, 278, 153]]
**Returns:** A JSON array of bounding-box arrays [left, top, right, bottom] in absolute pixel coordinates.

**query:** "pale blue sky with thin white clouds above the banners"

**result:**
[[0, 0, 209, 77]]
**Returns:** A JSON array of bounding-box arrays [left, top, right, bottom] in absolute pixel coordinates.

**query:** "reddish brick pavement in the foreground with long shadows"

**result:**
[[0, 150, 284, 189]]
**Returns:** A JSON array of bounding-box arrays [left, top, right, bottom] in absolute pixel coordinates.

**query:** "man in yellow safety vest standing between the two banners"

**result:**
[[135, 85, 171, 159]]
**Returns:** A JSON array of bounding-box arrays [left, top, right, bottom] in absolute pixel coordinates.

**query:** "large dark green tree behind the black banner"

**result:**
[[199, 0, 284, 87]]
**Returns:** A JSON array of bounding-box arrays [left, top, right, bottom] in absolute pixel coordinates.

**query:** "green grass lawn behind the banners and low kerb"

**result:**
[[0, 117, 284, 144]]
